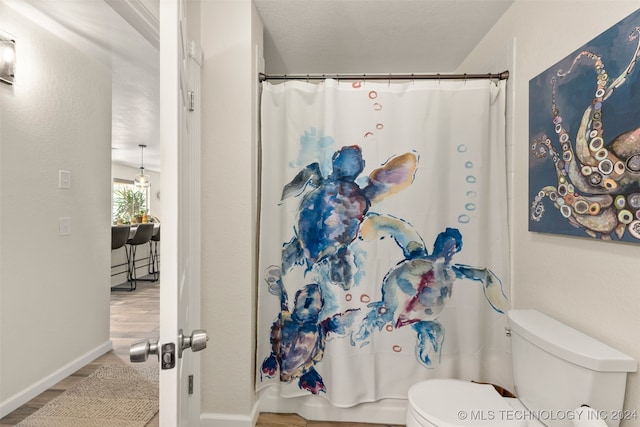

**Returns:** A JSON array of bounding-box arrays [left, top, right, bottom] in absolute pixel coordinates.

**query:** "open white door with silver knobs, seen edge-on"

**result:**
[[159, 0, 206, 427]]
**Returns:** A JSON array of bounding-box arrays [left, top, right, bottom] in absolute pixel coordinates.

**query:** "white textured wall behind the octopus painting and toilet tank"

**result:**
[[460, 0, 640, 427]]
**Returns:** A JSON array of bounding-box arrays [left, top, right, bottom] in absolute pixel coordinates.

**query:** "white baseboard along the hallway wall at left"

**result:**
[[0, 341, 113, 418]]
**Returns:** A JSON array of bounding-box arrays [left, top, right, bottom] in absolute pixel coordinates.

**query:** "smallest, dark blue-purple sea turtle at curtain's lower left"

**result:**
[[261, 267, 359, 394]]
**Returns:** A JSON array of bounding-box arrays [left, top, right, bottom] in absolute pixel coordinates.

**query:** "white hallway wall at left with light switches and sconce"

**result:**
[[0, 2, 111, 417]]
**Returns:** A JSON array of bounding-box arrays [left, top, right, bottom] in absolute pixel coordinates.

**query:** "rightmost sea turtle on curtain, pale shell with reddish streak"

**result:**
[[352, 213, 508, 368]]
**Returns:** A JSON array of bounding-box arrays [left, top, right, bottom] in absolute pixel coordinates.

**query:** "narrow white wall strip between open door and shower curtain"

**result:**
[[200, 0, 262, 427]]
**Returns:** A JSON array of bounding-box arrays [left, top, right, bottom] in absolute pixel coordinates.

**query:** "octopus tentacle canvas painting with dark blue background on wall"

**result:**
[[529, 10, 640, 243]]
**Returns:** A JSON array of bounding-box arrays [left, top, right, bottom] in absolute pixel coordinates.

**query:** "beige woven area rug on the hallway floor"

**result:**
[[18, 365, 159, 427]]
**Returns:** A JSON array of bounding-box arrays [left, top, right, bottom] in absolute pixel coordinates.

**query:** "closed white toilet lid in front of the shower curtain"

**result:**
[[409, 379, 527, 427]]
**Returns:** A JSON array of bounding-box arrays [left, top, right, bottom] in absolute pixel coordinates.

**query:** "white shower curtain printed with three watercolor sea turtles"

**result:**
[[256, 80, 513, 407]]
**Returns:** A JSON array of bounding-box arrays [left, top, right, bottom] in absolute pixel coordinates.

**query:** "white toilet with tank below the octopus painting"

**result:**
[[406, 310, 637, 427]]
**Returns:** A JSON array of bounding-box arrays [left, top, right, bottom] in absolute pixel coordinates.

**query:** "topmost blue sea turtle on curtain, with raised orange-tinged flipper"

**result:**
[[282, 145, 418, 289]]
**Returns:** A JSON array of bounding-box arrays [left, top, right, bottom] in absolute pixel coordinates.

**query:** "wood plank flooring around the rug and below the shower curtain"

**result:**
[[0, 282, 402, 427]]
